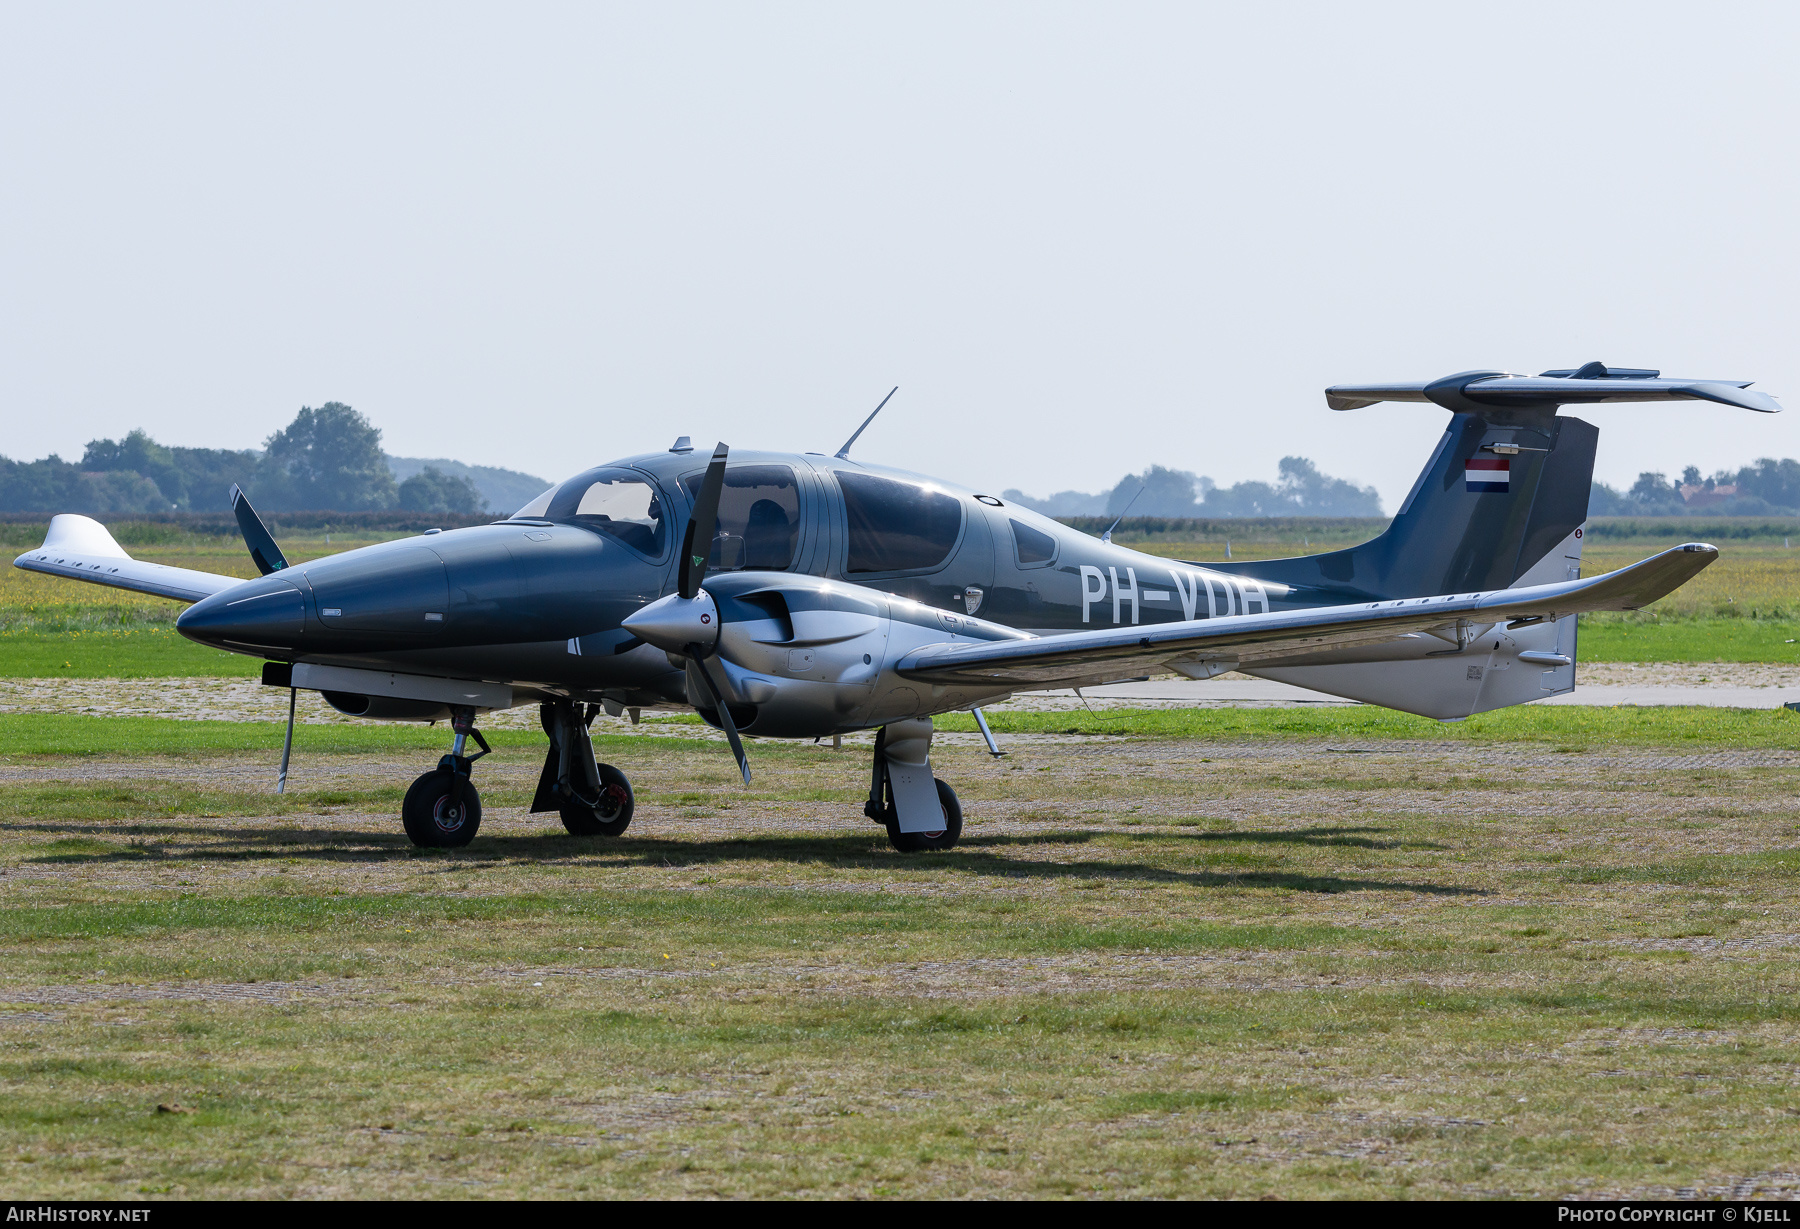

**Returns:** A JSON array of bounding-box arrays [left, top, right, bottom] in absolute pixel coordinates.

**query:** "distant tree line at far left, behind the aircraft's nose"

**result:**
[[0, 401, 486, 515]]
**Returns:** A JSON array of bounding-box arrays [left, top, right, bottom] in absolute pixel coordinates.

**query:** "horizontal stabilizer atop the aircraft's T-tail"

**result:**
[[1325, 363, 1782, 414]]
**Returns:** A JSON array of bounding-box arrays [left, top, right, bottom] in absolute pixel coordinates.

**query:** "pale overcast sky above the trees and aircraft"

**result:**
[[0, 0, 1800, 511]]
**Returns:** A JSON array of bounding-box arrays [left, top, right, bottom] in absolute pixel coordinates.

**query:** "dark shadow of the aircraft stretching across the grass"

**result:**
[[7, 821, 1487, 896]]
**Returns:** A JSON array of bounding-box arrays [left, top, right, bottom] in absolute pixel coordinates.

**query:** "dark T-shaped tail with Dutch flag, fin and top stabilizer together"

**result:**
[[1208, 363, 1780, 599]]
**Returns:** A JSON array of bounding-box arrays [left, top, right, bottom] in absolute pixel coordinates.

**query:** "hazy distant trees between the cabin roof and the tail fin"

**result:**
[[1001, 457, 1382, 518]]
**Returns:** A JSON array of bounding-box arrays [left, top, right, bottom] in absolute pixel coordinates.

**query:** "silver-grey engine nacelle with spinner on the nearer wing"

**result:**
[[625, 572, 1030, 738]]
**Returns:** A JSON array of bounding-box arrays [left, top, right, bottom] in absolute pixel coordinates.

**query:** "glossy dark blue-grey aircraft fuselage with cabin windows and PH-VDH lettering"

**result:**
[[178, 452, 1355, 705]]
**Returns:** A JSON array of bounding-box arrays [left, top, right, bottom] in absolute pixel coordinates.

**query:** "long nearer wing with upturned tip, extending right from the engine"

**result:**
[[896, 542, 1719, 691]]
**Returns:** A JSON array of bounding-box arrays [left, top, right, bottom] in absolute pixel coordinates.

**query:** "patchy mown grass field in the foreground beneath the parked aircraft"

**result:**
[[0, 711, 1800, 1198]]
